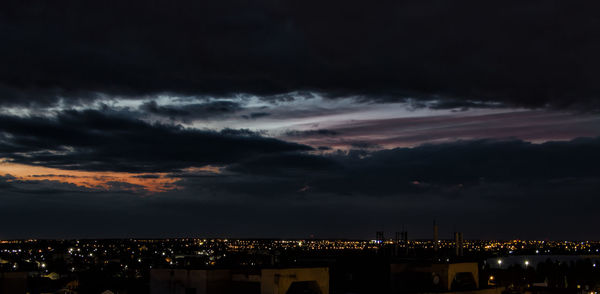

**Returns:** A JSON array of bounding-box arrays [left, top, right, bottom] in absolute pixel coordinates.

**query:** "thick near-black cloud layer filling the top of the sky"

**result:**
[[0, 0, 600, 112]]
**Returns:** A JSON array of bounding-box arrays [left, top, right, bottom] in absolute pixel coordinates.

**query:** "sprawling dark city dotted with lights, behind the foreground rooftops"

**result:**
[[0, 238, 600, 293]]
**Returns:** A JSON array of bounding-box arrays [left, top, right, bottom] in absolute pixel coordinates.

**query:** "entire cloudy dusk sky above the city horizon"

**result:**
[[0, 0, 600, 240]]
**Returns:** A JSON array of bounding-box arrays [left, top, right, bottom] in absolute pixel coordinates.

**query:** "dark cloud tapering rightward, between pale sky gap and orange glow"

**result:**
[[0, 110, 312, 172]]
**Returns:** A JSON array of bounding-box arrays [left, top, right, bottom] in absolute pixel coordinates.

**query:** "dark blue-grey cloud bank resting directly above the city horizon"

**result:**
[[0, 138, 600, 239]]
